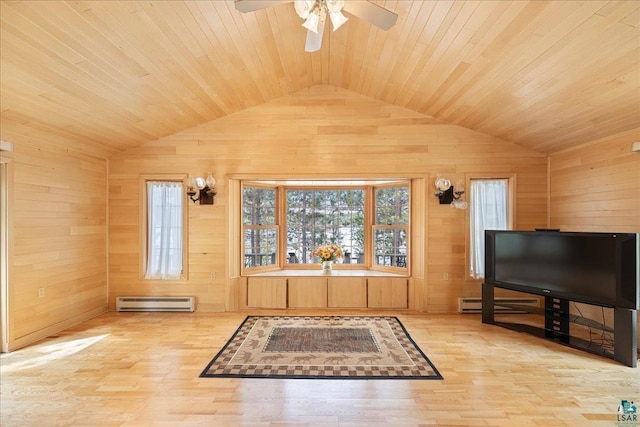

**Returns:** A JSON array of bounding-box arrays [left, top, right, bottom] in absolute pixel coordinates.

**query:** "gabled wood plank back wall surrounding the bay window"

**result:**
[[109, 86, 548, 312]]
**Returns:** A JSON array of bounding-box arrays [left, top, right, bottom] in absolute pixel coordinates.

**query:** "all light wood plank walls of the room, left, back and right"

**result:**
[[2, 86, 640, 349]]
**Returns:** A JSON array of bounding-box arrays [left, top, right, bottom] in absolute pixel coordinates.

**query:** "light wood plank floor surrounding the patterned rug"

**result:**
[[0, 311, 640, 427]]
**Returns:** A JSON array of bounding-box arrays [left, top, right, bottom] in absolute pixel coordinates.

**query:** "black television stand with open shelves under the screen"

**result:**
[[482, 283, 638, 368]]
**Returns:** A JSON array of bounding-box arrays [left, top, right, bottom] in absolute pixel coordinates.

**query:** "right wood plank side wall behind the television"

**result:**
[[549, 129, 640, 339]]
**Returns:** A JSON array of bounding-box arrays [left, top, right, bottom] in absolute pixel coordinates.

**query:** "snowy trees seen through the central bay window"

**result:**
[[242, 181, 410, 269]]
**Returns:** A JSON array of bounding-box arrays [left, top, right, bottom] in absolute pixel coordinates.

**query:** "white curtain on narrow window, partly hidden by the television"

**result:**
[[469, 179, 509, 279]]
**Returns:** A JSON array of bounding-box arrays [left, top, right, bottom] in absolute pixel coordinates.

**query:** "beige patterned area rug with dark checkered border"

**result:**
[[200, 316, 442, 379]]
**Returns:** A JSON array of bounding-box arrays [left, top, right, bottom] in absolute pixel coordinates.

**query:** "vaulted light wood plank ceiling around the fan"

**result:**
[[0, 0, 640, 157]]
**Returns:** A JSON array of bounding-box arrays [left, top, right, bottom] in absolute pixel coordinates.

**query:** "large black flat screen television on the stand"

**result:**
[[484, 230, 640, 310]]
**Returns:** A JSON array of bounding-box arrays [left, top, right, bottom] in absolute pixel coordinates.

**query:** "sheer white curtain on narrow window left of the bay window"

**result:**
[[144, 181, 183, 280]]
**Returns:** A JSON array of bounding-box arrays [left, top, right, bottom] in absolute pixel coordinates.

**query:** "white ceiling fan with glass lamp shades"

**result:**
[[235, 0, 398, 52]]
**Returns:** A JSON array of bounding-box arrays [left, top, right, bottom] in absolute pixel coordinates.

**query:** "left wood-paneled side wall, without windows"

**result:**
[[2, 136, 108, 350]]
